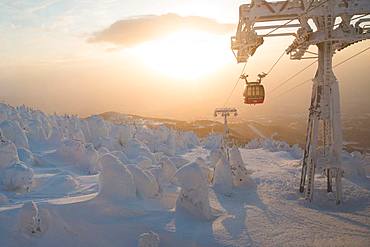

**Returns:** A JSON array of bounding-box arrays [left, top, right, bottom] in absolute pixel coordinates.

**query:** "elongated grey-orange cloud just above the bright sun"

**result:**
[[88, 14, 235, 47]]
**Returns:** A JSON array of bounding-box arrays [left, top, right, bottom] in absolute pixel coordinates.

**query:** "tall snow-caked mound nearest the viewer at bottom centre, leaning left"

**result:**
[[175, 162, 213, 220]]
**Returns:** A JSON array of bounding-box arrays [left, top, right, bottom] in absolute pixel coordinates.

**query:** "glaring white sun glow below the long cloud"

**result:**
[[128, 30, 232, 80]]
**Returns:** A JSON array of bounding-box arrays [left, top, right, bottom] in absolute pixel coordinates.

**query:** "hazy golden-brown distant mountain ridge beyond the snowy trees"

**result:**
[[100, 112, 370, 153]]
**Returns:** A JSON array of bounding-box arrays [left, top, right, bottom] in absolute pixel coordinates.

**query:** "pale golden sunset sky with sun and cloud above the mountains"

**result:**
[[0, 0, 370, 119]]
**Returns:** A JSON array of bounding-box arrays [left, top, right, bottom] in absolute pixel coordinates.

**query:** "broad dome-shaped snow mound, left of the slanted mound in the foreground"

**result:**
[[98, 154, 136, 200]]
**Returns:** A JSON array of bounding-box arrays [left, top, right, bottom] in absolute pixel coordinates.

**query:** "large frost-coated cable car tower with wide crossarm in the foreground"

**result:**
[[231, 0, 370, 204]]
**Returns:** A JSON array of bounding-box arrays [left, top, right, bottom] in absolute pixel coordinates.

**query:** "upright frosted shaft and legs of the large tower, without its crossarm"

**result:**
[[300, 16, 343, 204]]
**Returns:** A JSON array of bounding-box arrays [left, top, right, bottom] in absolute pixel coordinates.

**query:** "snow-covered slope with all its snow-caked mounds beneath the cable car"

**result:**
[[0, 105, 370, 247]]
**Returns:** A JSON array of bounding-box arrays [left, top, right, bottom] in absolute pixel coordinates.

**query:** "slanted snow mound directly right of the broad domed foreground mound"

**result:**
[[127, 165, 159, 198]]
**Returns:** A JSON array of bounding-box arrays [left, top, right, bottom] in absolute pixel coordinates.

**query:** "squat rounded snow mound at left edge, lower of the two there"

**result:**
[[1, 163, 34, 192]]
